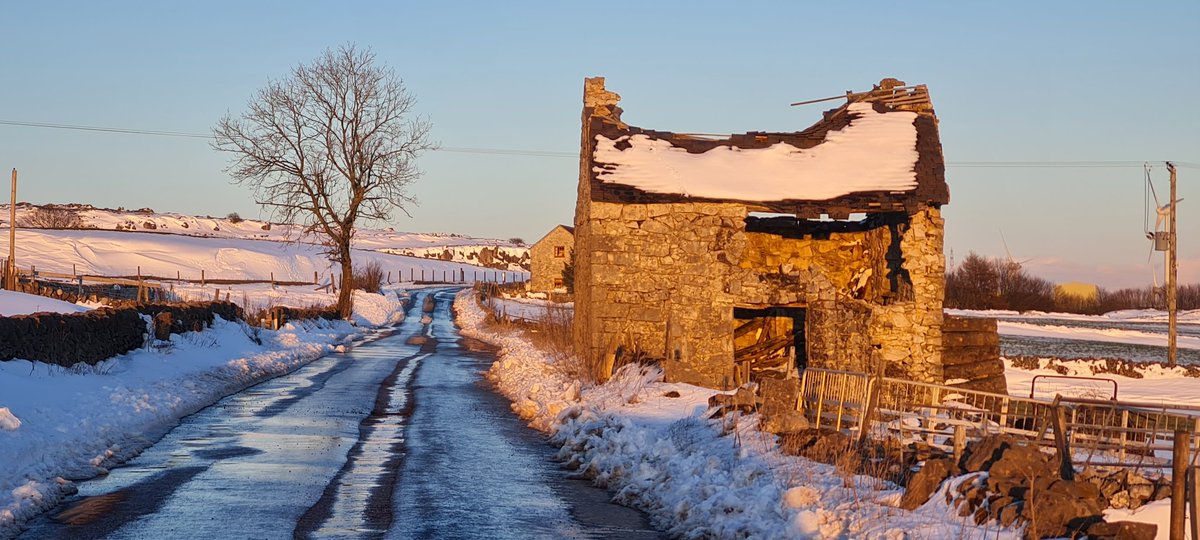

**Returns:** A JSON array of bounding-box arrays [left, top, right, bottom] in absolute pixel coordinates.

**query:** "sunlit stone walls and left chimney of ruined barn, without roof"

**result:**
[[574, 78, 944, 388]]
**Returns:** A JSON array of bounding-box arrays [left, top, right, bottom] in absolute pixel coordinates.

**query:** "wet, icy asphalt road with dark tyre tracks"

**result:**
[[20, 290, 659, 539]]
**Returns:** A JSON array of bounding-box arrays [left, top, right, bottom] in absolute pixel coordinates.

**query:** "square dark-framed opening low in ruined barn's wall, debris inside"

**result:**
[[733, 307, 809, 382]]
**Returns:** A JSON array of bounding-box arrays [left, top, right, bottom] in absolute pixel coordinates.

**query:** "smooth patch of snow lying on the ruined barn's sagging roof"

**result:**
[[593, 103, 918, 200]]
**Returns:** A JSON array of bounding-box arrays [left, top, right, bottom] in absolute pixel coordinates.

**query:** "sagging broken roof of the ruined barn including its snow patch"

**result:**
[[586, 78, 949, 217]]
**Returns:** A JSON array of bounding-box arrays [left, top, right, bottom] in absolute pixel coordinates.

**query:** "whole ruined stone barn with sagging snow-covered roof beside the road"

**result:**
[[574, 78, 993, 388]]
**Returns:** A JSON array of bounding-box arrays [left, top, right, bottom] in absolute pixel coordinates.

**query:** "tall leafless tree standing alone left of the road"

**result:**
[[214, 46, 433, 318]]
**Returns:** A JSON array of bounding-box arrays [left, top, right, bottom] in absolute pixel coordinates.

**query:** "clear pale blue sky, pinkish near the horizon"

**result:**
[[0, 0, 1200, 287]]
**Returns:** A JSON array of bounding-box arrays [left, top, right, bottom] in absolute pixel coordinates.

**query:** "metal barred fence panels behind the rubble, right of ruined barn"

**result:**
[[797, 368, 1200, 467]]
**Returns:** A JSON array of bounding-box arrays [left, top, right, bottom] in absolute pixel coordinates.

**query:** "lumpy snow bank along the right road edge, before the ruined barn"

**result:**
[[455, 290, 1016, 539]]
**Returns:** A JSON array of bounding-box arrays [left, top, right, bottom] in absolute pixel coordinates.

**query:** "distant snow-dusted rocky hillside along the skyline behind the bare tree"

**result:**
[[0, 203, 529, 271]]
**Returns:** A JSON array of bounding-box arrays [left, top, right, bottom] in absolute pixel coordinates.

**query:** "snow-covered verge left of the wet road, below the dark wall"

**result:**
[[0, 293, 403, 538]]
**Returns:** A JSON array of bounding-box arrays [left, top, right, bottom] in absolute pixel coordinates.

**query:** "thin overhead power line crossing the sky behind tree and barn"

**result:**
[[0, 120, 1200, 168]]
